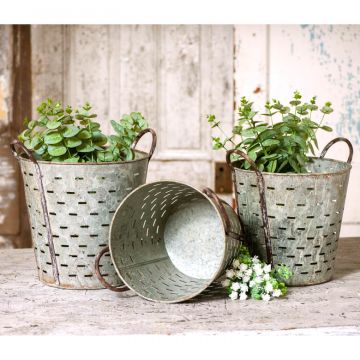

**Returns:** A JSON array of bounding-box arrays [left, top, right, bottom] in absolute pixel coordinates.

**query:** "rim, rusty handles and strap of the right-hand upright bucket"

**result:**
[[226, 137, 354, 266]]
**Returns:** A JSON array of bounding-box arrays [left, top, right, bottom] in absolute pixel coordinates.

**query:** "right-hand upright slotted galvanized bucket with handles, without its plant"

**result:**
[[226, 138, 353, 285]]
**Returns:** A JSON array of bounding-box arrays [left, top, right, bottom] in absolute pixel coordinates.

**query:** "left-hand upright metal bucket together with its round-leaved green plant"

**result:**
[[11, 99, 156, 289]]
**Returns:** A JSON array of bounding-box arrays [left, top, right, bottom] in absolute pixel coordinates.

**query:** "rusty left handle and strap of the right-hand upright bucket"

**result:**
[[226, 149, 273, 265]]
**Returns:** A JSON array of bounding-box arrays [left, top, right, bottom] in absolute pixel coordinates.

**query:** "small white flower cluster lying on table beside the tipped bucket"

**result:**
[[222, 256, 282, 301]]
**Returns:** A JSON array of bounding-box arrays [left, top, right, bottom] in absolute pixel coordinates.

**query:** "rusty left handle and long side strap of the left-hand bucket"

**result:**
[[10, 140, 60, 285]]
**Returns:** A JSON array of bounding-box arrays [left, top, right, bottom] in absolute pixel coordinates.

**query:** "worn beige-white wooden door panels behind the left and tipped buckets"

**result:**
[[32, 25, 233, 191]]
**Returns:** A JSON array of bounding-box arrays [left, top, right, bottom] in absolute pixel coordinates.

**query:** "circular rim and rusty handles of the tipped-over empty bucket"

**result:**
[[95, 180, 241, 304]]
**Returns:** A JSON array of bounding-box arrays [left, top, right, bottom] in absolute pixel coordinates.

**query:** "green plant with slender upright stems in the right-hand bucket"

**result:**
[[207, 91, 333, 173]]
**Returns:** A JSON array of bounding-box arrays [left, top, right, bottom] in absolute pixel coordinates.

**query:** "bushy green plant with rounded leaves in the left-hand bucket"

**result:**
[[18, 99, 148, 162]]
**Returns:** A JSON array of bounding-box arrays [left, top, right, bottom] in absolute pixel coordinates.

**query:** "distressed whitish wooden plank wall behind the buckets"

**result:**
[[0, 25, 360, 247]]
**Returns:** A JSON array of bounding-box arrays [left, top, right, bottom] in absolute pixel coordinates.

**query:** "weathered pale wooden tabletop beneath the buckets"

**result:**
[[0, 238, 360, 335]]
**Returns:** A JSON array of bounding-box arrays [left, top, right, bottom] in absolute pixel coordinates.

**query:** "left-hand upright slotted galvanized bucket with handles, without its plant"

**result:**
[[11, 129, 156, 289]]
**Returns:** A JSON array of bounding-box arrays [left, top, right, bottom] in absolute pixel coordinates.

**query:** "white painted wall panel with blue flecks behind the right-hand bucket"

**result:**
[[235, 25, 360, 236]]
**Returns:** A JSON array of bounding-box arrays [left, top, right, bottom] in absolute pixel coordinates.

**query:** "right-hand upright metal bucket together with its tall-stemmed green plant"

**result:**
[[208, 91, 353, 285]]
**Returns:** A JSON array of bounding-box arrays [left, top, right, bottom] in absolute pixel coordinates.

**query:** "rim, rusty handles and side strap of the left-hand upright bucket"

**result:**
[[10, 128, 157, 287]]
